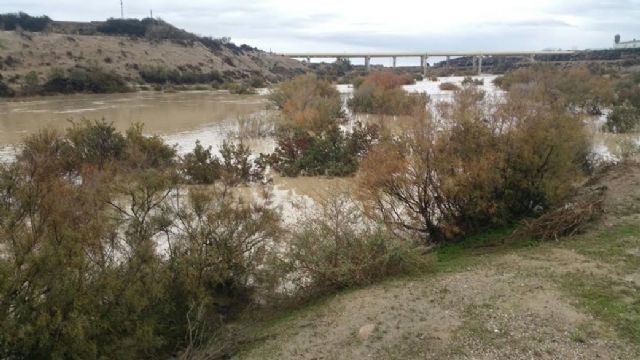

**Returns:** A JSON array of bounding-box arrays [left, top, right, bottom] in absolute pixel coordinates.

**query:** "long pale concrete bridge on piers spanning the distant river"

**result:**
[[282, 50, 575, 75]]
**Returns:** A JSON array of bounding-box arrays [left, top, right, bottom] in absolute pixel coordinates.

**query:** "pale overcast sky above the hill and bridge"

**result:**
[[5, 0, 640, 61]]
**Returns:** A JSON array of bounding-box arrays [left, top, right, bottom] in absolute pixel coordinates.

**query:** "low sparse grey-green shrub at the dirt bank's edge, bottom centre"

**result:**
[[285, 195, 432, 295]]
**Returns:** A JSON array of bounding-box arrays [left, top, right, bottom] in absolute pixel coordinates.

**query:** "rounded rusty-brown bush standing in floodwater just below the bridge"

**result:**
[[349, 71, 427, 115]]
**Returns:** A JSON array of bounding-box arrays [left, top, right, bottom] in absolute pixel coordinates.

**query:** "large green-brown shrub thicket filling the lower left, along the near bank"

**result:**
[[0, 116, 419, 358]]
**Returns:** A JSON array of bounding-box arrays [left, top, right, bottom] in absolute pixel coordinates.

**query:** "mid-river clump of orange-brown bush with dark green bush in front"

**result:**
[[266, 75, 378, 176]]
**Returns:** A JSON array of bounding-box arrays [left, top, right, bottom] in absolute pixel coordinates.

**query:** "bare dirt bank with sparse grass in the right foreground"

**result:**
[[232, 165, 640, 359]]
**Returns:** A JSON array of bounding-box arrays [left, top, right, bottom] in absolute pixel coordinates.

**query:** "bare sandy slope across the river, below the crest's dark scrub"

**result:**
[[0, 31, 305, 85]]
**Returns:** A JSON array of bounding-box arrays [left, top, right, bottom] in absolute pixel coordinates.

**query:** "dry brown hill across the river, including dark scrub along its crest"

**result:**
[[0, 18, 306, 88]]
